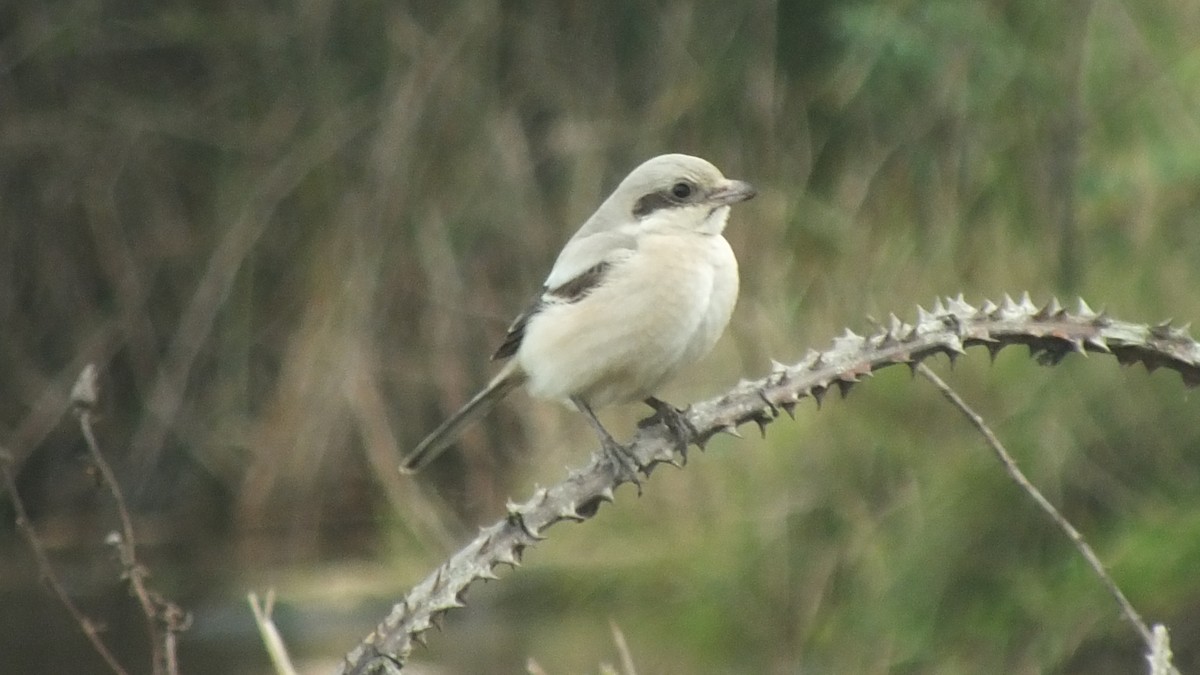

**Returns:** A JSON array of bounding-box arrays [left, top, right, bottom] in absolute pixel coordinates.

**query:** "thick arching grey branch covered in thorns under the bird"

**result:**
[[338, 294, 1200, 674]]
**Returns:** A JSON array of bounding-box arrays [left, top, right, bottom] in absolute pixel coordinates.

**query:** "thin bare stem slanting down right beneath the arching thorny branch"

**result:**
[[917, 363, 1154, 651]]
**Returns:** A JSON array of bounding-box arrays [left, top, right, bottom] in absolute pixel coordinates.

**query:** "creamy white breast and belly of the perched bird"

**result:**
[[516, 234, 738, 407]]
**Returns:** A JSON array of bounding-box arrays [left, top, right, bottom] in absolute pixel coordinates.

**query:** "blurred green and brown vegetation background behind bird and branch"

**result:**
[[0, 0, 1200, 674]]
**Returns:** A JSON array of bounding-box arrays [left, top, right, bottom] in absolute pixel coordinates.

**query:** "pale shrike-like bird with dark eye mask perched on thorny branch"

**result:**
[[401, 154, 756, 480]]
